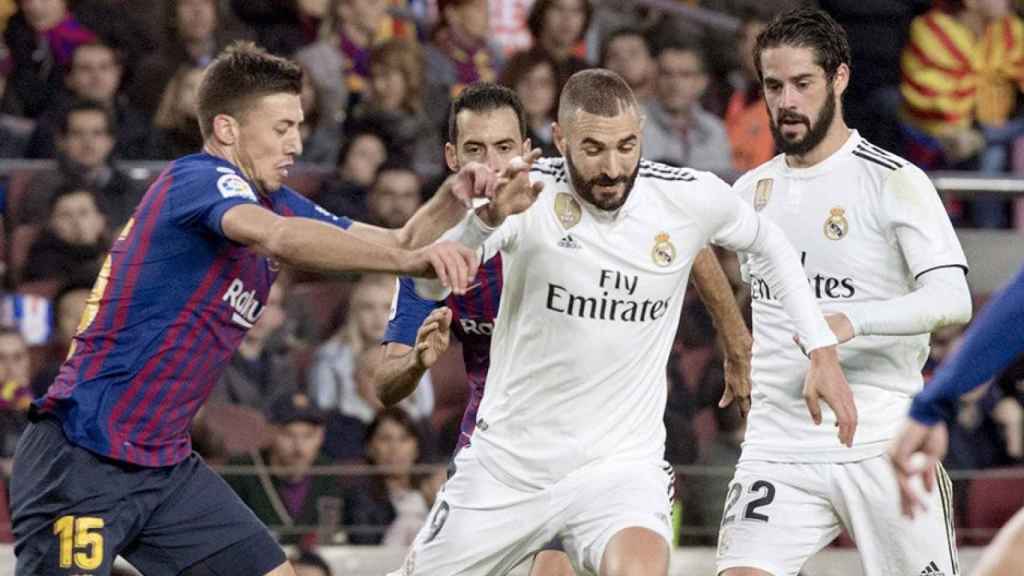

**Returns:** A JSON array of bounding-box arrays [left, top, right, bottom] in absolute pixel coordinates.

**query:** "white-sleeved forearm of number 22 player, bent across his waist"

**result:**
[[843, 268, 972, 336]]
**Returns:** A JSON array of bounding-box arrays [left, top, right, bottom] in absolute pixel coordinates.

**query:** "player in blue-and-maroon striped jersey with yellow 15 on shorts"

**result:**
[[11, 43, 489, 576]]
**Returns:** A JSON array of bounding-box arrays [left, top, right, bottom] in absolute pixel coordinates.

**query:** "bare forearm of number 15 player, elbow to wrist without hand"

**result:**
[[270, 217, 413, 274]]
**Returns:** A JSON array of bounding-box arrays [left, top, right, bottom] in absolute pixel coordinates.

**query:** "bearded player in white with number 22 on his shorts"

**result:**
[[718, 8, 971, 576]]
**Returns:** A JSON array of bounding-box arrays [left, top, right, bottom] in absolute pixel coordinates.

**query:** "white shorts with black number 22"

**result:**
[[718, 456, 959, 576]]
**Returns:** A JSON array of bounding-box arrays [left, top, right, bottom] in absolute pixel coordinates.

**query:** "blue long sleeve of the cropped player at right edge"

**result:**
[[910, 269, 1024, 425]]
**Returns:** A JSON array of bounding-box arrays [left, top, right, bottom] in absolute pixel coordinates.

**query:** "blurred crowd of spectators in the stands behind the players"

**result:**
[[0, 0, 1024, 545]]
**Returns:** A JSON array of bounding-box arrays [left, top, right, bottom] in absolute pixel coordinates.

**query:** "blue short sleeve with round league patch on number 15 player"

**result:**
[[168, 162, 259, 237]]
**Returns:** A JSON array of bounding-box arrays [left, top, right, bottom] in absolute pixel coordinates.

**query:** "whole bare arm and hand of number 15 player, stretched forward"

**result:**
[[220, 204, 477, 288]]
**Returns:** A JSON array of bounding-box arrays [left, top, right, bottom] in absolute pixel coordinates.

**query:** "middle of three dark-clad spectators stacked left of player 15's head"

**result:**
[[15, 100, 143, 229]]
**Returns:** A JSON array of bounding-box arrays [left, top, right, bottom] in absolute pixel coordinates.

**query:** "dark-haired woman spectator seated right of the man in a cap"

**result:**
[[344, 407, 433, 545]]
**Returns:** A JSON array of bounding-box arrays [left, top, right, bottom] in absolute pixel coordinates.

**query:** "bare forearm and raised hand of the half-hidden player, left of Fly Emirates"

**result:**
[[371, 307, 452, 406]]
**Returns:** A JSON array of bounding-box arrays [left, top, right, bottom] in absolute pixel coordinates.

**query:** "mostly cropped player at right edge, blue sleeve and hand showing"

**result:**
[[889, 262, 1024, 576]]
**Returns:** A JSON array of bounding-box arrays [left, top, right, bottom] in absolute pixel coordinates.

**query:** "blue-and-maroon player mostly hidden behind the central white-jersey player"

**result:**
[[374, 84, 751, 576]]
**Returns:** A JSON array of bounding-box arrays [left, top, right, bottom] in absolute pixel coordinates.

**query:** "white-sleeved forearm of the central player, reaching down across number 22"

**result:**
[[748, 217, 837, 353]]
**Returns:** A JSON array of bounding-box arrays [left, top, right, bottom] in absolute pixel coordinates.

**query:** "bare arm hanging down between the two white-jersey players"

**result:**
[[692, 243, 753, 416]]
